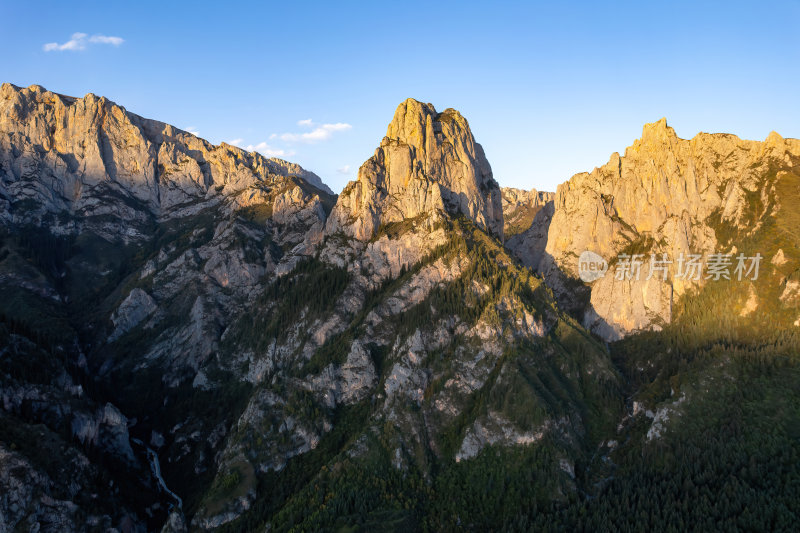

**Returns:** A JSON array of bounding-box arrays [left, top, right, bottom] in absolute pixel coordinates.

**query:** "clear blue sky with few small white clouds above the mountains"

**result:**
[[0, 1, 800, 192]]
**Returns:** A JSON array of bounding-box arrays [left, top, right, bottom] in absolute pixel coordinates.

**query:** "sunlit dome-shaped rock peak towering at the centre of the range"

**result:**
[[326, 99, 503, 240]]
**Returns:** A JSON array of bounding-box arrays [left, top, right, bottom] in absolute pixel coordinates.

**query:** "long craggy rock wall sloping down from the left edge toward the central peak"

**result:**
[[0, 83, 332, 241]]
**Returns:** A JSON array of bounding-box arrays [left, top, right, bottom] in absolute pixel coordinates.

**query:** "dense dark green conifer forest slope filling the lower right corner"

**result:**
[[556, 348, 800, 531]]
